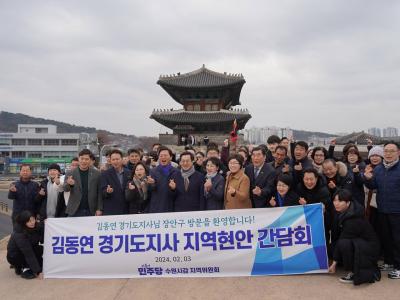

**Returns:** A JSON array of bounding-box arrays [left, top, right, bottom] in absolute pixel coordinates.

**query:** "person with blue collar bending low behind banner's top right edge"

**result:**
[[269, 174, 300, 207]]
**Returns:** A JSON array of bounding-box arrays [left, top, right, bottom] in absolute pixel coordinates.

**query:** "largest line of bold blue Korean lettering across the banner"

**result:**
[[52, 225, 312, 255]]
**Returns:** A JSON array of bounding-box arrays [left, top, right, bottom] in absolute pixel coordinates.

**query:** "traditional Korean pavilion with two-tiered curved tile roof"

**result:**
[[150, 65, 251, 145]]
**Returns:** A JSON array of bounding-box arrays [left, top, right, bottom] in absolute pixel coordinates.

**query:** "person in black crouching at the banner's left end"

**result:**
[[7, 210, 43, 279]]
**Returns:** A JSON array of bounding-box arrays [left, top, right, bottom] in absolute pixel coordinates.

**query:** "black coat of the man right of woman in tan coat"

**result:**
[[244, 162, 276, 208]]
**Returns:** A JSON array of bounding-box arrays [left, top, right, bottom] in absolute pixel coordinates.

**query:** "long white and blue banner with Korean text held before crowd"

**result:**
[[43, 204, 328, 278]]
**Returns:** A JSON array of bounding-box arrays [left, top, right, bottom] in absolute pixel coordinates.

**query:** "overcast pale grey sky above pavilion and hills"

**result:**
[[0, 0, 400, 136]]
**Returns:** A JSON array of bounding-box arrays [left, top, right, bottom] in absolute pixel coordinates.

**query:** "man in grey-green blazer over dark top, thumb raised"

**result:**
[[64, 149, 103, 217]]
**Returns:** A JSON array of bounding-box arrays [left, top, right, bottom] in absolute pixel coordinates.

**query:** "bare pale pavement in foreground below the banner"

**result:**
[[0, 244, 400, 300]]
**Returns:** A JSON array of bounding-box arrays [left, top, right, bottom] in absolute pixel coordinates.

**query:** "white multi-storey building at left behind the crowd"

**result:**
[[0, 124, 98, 174]]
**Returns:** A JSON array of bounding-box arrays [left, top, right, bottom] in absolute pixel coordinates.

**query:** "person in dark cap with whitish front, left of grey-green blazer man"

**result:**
[[36, 164, 65, 221]]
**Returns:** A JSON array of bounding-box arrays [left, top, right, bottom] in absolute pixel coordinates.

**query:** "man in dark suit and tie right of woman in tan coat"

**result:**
[[245, 147, 276, 208]]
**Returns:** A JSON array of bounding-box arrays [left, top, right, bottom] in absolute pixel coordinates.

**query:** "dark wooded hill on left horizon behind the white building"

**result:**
[[0, 111, 158, 149]]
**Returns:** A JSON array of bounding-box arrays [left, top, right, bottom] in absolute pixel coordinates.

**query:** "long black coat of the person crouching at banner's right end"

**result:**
[[333, 202, 380, 284]]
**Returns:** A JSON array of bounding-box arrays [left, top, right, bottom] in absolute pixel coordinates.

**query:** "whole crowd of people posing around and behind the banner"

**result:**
[[7, 136, 400, 284]]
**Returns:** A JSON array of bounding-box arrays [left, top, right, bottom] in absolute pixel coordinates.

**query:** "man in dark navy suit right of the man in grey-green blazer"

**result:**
[[101, 149, 130, 215]]
